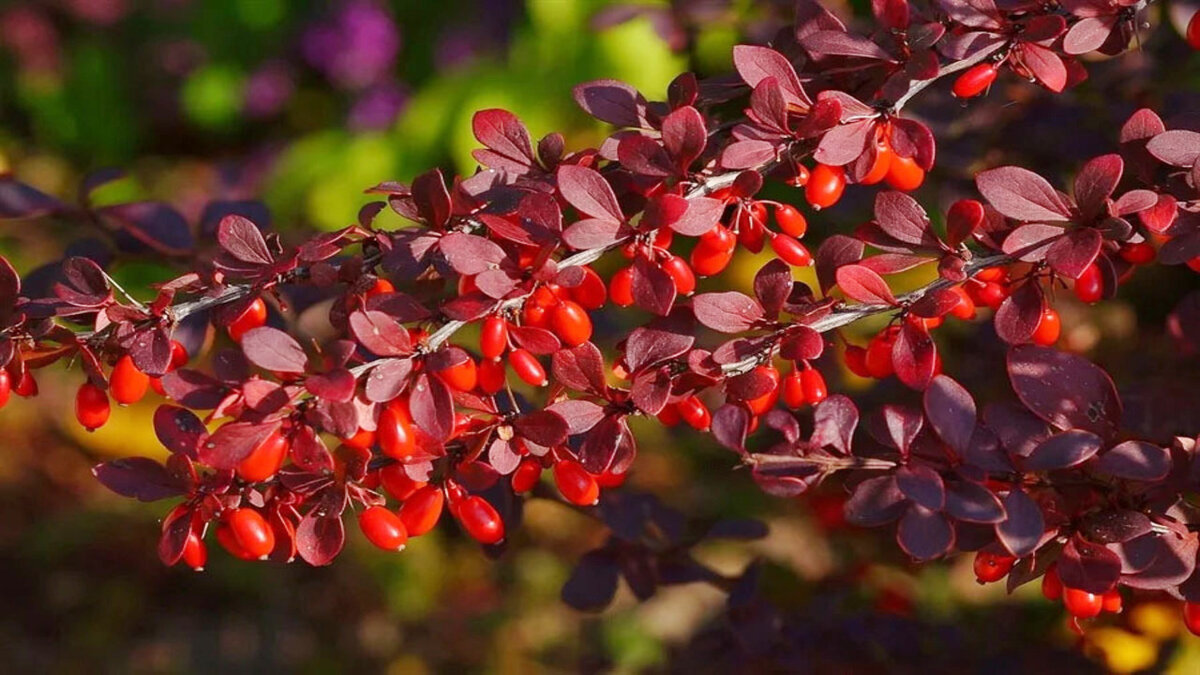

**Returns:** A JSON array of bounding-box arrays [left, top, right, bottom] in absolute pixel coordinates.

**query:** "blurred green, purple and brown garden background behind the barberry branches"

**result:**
[[7, 0, 1200, 674]]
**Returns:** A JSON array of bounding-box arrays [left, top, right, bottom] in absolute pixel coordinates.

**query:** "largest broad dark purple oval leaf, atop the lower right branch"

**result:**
[[1008, 345, 1121, 437]]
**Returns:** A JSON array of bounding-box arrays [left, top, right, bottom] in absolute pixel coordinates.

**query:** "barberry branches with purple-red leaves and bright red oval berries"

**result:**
[[0, 0, 1200, 627]]
